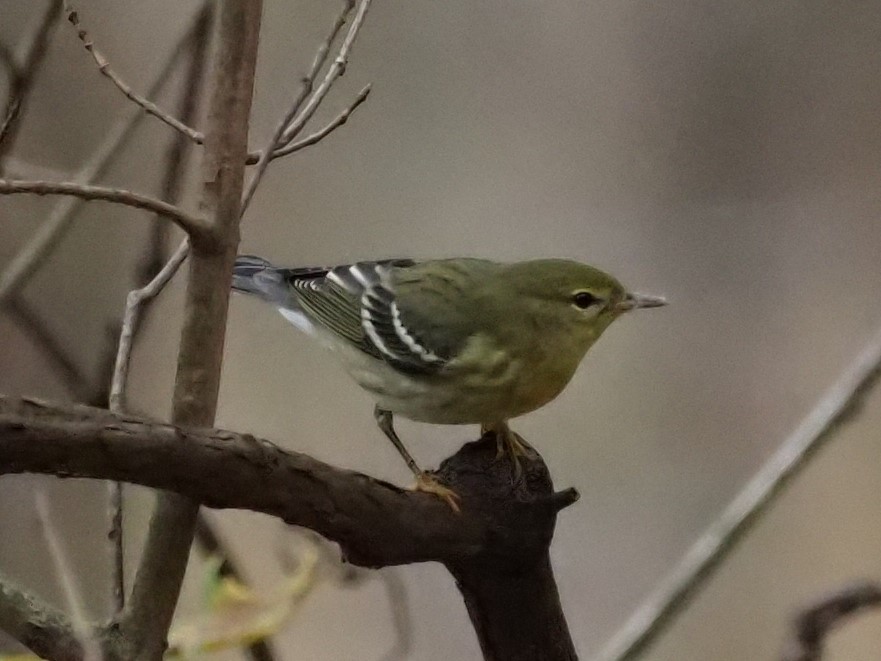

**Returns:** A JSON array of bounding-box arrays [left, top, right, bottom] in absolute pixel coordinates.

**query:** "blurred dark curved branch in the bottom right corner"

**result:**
[[783, 581, 881, 661]]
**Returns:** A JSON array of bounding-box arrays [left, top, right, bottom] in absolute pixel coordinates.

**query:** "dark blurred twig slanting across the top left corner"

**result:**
[[0, 0, 61, 164]]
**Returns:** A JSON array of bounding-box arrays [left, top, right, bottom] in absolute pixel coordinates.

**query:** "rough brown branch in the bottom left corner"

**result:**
[[0, 575, 83, 661]]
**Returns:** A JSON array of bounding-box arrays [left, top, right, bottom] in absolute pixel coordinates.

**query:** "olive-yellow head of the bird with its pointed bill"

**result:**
[[498, 259, 667, 350]]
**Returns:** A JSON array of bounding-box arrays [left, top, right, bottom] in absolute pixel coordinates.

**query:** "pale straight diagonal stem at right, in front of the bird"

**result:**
[[596, 324, 881, 661]]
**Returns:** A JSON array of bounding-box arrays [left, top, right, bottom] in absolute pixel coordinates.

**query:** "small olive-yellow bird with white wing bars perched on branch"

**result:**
[[232, 255, 666, 511]]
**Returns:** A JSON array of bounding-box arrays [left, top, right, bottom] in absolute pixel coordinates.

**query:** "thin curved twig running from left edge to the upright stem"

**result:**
[[0, 179, 211, 239]]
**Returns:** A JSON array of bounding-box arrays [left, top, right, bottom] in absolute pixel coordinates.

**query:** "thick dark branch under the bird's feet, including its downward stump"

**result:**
[[0, 398, 578, 661]]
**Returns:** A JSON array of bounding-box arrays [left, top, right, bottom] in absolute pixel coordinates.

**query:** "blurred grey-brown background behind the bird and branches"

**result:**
[[0, 0, 881, 661]]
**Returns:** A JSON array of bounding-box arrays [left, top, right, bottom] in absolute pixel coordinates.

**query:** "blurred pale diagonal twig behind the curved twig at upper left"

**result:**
[[0, 6, 211, 305]]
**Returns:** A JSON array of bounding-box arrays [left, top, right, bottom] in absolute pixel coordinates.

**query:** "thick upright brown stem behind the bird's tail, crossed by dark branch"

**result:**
[[121, 0, 262, 659]]
